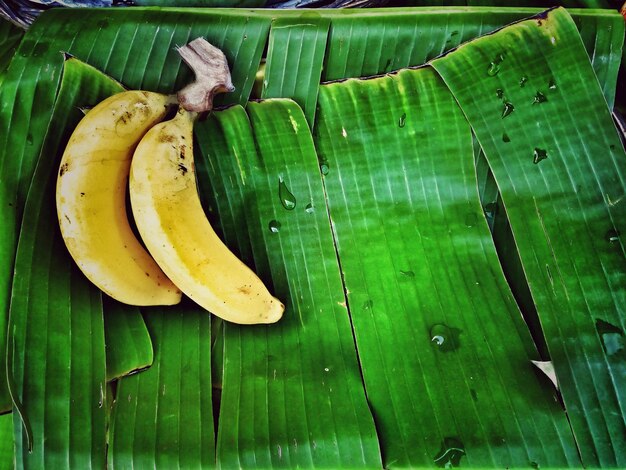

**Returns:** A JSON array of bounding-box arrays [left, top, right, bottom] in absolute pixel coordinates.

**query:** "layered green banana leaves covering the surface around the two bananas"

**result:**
[[0, 7, 626, 469]]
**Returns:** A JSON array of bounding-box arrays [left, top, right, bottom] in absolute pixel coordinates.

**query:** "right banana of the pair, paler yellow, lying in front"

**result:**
[[130, 108, 285, 324]]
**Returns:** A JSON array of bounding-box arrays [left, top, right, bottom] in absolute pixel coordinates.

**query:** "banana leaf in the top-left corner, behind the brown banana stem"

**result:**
[[0, 9, 269, 409]]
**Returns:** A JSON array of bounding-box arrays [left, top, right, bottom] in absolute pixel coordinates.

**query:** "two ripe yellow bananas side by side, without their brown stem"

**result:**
[[56, 91, 284, 324]]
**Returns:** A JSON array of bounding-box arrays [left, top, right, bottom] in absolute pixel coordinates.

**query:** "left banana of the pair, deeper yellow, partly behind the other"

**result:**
[[56, 91, 181, 305]]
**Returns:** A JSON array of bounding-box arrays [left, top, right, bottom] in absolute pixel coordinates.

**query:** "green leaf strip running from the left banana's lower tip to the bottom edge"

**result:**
[[107, 302, 215, 469]]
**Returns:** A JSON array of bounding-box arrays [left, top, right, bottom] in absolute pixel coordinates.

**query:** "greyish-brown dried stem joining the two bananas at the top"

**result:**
[[177, 38, 235, 113]]
